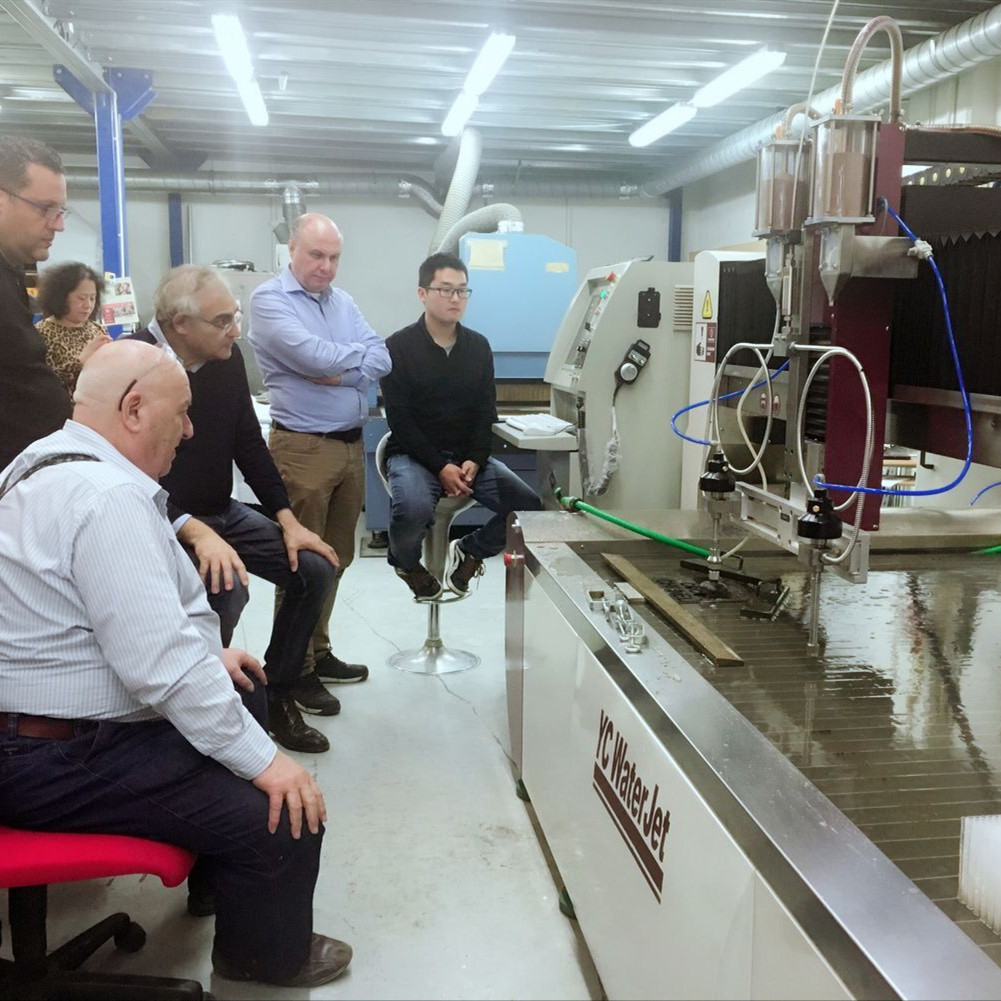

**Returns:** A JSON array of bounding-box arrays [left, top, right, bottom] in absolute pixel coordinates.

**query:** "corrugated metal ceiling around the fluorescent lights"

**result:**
[[0, 0, 995, 184]]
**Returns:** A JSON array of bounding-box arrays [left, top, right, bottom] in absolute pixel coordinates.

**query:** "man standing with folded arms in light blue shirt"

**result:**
[[248, 212, 390, 715]]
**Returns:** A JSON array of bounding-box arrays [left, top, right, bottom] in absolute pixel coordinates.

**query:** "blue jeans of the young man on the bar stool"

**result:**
[[385, 455, 543, 570]]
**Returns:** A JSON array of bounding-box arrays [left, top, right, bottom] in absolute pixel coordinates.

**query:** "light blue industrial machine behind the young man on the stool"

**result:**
[[364, 232, 577, 533]]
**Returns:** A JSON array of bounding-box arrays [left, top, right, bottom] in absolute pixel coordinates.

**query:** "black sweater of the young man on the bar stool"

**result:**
[[381, 316, 497, 473]]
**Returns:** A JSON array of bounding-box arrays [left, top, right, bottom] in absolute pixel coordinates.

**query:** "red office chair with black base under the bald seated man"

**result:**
[[0, 826, 209, 1001]]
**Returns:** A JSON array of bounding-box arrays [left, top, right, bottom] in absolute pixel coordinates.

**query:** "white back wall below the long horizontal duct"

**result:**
[[60, 189, 670, 335]]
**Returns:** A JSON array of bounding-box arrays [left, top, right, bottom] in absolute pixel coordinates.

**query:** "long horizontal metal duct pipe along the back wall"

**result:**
[[66, 167, 640, 201]]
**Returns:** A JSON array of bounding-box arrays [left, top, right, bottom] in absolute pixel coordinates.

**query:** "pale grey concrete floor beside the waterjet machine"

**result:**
[[4, 536, 604, 999]]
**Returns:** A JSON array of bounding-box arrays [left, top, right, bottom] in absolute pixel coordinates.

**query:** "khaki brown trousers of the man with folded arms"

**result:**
[[268, 428, 365, 674]]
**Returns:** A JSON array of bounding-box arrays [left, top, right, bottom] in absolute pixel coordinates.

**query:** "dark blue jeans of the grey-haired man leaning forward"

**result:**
[[182, 501, 336, 691]]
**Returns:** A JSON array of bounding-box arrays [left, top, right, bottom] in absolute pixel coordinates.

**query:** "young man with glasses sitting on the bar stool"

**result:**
[[382, 253, 542, 602]]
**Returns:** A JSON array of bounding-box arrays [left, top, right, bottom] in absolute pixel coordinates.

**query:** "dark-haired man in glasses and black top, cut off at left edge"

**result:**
[[0, 136, 72, 467]]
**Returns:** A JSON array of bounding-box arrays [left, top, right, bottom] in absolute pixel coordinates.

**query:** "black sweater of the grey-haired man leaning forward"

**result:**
[[131, 330, 291, 521]]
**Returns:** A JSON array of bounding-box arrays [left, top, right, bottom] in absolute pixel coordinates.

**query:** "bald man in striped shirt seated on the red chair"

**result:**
[[0, 341, 351, 987]]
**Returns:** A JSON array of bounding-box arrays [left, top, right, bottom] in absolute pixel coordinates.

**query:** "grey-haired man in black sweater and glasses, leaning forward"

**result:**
[[133, 264, 337, 756]]
